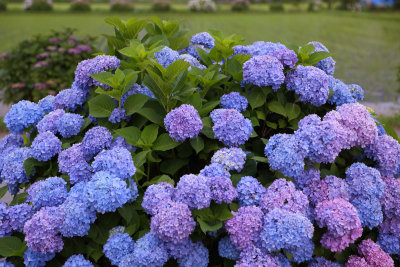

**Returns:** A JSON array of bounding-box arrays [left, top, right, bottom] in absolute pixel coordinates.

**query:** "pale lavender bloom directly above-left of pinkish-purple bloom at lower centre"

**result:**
[[142, 182, 175, 215]]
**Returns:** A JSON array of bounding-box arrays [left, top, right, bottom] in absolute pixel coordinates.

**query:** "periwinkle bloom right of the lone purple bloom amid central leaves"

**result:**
[[210, 109, 253, 147]]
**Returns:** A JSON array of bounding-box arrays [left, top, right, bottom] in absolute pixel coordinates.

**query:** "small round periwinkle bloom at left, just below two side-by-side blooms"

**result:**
[[31, 132, 62, 161]]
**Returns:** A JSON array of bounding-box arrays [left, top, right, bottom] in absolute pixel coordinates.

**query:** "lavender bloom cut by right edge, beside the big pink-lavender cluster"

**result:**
[[365, 134, 400, 176]]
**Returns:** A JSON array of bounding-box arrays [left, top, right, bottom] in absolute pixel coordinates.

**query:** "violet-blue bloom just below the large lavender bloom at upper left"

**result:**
[[53, 89, 87, 111]]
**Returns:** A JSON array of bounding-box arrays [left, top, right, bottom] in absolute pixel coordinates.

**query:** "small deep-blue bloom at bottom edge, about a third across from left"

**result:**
[[103, 233, 135, 266]]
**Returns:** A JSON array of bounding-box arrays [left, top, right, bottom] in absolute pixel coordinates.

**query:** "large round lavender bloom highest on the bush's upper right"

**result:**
[[243, 55, 285, 91]]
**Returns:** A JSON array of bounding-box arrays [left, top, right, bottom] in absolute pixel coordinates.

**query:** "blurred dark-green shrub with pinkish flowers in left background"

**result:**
[[0, 29, 95, 103]]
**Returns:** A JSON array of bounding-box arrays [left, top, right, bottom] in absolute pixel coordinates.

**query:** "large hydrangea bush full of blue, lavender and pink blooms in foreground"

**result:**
[[0, 17, 400, 267]]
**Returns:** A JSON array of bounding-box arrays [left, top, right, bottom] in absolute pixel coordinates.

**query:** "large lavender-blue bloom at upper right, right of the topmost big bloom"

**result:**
[[285, 65, 329, 107]]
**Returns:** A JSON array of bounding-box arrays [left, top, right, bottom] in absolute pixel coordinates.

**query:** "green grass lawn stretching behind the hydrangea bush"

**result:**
[[0, 4, 400, 101]]
